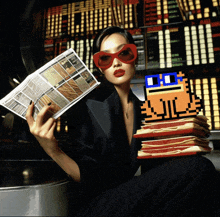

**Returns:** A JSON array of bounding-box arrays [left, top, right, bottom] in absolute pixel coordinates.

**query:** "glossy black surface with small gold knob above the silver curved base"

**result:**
[[0, 160, 67, 188]]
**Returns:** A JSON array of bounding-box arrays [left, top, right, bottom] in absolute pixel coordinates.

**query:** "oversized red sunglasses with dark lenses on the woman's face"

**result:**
[[93, 44, 137, 69]]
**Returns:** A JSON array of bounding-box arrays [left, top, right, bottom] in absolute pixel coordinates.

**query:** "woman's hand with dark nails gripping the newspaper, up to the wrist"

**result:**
[[26, 102, 59, 156]]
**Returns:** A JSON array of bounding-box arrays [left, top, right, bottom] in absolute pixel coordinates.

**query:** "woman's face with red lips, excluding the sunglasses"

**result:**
[[100, 33, 135, 86]]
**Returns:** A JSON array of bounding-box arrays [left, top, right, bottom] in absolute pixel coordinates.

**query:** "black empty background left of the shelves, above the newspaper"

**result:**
[[0, 0, 79, 98]]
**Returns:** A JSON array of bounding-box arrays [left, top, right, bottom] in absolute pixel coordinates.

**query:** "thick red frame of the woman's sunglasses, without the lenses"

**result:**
[[93, 44, 137, 69]]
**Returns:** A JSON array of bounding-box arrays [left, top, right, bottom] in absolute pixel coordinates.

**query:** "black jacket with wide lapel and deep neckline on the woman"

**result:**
[[64, 82, 144, 200]]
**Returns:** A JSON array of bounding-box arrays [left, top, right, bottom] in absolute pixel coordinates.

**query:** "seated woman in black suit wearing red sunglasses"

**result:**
[[26, 27, 218, 216]]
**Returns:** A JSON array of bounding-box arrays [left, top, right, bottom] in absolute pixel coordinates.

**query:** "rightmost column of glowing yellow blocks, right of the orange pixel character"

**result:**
[[211, 78, 220, 129]]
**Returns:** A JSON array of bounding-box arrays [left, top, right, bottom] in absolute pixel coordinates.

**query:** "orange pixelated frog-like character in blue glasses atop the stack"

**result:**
[[141, 72, 202, 121]]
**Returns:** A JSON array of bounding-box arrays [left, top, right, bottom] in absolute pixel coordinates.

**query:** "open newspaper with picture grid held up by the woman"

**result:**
[[0, 48, 100, 119]]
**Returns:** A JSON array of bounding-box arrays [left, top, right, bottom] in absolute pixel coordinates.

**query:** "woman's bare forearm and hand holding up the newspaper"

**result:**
[[26, 102, 80, 182]]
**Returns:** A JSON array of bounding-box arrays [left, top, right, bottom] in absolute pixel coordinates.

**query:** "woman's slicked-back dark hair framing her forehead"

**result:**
[[93, 26, 134, 54]]
